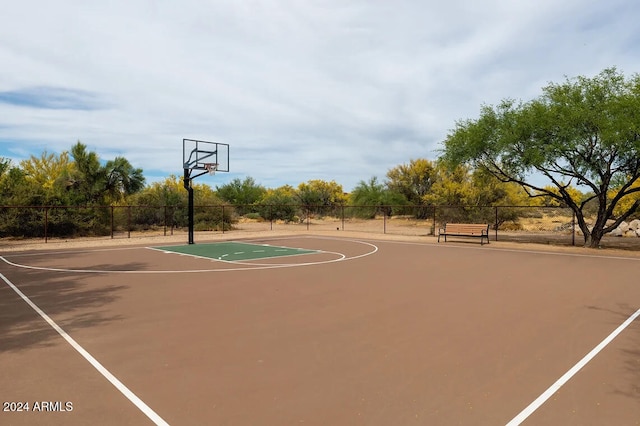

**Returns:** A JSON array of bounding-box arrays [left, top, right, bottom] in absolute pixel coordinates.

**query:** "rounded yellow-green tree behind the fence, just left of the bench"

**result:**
[[387, 158, 436, 219]]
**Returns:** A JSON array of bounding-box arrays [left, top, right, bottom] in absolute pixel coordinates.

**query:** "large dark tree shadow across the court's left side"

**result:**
[[0, 263, 142, 353]]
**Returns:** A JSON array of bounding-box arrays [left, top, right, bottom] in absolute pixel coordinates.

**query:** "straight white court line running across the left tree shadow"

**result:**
[[0, 273, 169, 426]]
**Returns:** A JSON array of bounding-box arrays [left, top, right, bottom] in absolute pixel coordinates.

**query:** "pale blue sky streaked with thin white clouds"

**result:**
[[0, 0, 640, 191]]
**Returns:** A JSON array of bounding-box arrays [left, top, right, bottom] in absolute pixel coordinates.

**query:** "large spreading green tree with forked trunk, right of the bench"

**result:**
[[443, 68, 640, 247]]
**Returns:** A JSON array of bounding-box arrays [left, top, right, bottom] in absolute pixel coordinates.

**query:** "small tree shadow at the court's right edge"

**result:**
[[588, 303, 640, 401]]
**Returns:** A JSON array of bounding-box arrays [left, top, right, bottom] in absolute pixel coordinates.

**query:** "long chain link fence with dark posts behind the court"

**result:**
[[0, 204, 640, 249]]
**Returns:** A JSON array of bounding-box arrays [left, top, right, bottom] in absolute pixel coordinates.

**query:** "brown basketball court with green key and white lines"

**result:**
[[0, 235, 640, 425]]
